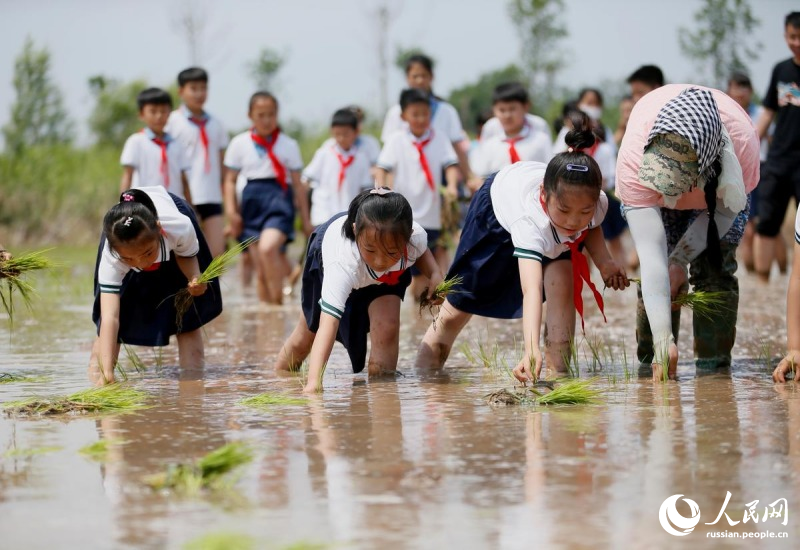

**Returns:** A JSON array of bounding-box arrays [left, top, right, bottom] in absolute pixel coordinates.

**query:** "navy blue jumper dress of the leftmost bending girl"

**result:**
[[92, 193, 222, 346]]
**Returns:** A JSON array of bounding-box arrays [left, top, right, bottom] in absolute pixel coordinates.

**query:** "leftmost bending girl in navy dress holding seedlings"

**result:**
[[89, 187, 222, 384]]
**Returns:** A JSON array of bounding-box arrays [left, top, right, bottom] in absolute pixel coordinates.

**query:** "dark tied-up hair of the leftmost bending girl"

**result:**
[[103, 189, 159, 248]]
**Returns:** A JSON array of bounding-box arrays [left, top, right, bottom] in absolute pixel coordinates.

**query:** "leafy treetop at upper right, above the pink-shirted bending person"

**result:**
[[678, 0, 762, 87]]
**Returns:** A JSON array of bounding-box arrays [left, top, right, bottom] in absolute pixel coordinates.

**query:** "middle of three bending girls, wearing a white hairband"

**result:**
[[277, 189, 442, 392]]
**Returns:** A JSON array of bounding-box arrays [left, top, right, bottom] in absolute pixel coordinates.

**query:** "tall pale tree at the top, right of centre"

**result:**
[[509, 0, 567, 112]]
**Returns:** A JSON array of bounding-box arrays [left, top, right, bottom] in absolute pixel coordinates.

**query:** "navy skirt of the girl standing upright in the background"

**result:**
[[239, 178, 294, 242]]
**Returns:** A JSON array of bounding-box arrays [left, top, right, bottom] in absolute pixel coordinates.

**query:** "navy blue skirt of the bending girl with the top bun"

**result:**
[[447, 174, 572, 319]]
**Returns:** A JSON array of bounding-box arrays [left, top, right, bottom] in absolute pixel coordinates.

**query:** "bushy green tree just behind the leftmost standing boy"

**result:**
[[89, 75, 149, 147]]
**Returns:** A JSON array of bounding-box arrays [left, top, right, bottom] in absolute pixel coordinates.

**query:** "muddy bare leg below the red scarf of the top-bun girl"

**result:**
[[544, 260, 577, 376]]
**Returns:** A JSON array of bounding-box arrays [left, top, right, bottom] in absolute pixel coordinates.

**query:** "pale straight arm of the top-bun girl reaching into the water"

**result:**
[[514, 258, 544, 384]]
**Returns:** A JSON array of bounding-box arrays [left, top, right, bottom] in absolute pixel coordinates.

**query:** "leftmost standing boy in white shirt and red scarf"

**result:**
[[120, 88, 192, 204]]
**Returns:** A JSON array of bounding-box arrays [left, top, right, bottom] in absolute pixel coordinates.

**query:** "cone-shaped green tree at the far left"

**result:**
[[3, 38, 73, 153]]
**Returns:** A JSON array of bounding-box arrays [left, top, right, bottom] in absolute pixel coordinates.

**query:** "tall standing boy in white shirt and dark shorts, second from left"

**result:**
[[166, 67, 228, 256]]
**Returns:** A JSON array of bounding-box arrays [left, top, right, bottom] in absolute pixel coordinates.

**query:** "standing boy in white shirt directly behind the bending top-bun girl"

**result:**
[[472, 82, 551, 183]]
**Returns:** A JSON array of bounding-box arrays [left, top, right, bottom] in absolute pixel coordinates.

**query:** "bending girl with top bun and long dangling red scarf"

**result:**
[[417, 113, 629, 382]]
